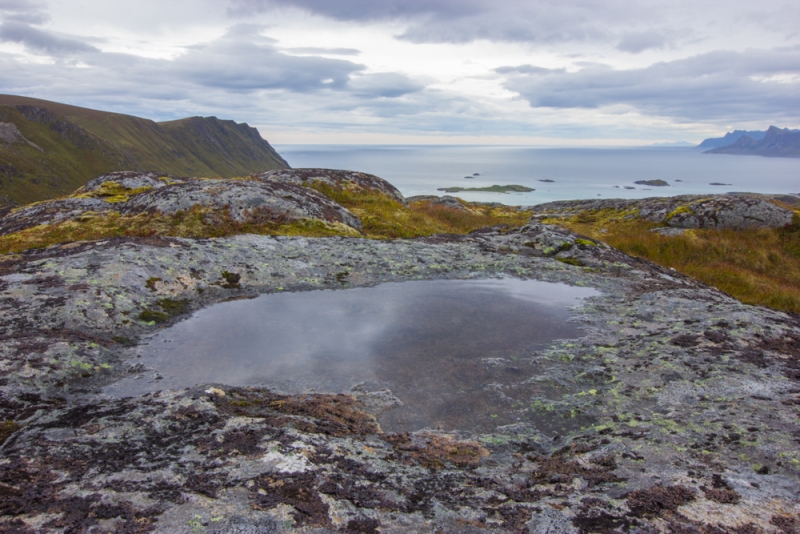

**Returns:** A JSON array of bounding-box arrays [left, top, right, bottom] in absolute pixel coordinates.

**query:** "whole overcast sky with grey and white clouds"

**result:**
[[0, 0, 800, 145]]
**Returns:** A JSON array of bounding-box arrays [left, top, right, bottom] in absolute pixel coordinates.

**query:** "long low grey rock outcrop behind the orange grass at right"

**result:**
[[530, 195, 793, 228]]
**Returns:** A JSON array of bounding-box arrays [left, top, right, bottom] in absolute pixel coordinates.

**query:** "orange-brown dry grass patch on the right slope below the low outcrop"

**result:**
[[552, 206, 800, 313]]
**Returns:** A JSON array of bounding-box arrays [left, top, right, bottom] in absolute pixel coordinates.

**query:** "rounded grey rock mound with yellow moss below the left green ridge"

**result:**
[[0, 171, 361, 234]]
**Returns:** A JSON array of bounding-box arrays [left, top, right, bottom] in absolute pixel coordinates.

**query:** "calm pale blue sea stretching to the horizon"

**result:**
[[275, 145, 800, 205]]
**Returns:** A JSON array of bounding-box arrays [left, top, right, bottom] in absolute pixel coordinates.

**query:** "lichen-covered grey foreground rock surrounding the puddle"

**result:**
[[0, 220, 800, 533]]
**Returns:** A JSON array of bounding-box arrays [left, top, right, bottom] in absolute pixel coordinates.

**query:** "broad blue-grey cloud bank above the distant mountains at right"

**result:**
[[496, 48, 800, 122]]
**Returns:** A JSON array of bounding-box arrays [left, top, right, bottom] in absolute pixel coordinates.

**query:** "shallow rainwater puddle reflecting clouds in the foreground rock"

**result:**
[[105, 278, 599, 432]]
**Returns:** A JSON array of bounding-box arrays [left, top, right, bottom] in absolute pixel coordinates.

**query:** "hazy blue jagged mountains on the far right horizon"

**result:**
[[697, 126, 800, 157]]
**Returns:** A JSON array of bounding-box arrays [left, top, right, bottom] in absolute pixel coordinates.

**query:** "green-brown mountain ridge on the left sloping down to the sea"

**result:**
[[0, 95, 289, 205]]
